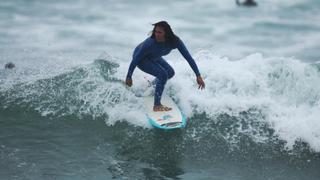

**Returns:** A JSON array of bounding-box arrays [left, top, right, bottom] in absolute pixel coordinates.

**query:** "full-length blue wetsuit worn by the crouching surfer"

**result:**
[[127, 37, 200, 106]]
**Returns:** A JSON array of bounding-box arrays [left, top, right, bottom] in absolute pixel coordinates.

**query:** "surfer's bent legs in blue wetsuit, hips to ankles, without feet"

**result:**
[[138, 58, 174, 106]]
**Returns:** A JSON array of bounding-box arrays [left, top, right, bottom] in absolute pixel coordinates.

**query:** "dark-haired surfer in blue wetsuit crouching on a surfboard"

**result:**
[[126, 21, 205, 111]]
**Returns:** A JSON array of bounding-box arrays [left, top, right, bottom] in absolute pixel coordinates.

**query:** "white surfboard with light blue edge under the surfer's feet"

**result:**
[[144, 96, 186, 129]]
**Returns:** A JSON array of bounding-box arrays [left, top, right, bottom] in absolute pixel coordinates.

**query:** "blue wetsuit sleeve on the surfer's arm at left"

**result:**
[[127, 40, 151, 79]]
